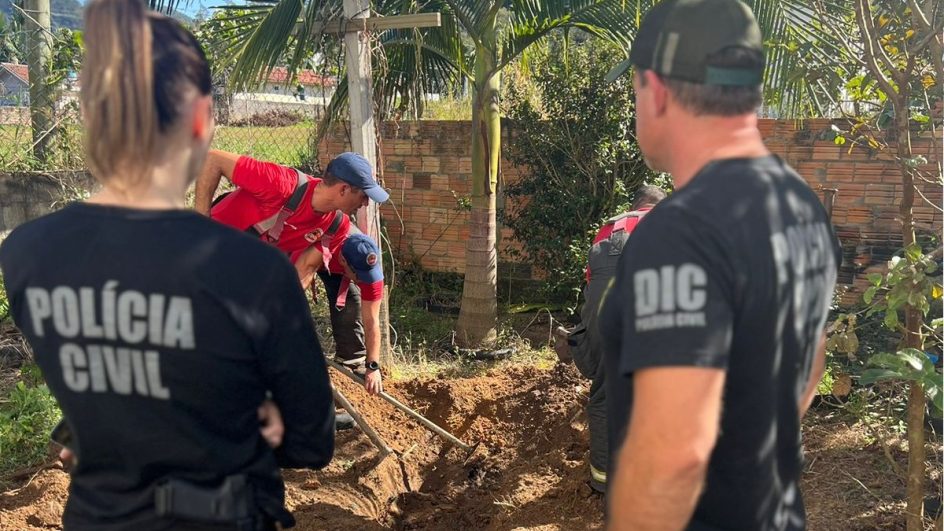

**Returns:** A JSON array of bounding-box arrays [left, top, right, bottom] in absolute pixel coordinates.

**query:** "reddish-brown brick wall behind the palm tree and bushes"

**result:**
[[320, 120, 942, 301]]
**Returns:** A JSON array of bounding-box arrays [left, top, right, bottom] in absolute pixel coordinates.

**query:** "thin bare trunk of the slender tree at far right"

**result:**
[[894, 95, 927, 531]]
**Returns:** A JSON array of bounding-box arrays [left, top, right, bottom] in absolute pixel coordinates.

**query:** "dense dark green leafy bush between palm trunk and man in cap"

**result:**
[[500, 35, 670, 302]]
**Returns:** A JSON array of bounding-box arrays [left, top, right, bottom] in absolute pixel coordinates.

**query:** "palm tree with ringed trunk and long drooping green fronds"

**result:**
[[203, 0, 841, 346]]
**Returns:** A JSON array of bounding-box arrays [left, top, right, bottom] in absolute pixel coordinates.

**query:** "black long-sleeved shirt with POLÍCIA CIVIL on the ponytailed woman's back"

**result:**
[[0, 204, 334, 531]]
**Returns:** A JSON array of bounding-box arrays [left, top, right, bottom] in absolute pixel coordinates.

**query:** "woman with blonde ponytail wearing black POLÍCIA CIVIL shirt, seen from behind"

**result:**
[[0, 0, 334, 531]]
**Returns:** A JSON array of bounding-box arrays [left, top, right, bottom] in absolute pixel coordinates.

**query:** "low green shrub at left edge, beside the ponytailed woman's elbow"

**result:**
[[0, 378, 62, 478]]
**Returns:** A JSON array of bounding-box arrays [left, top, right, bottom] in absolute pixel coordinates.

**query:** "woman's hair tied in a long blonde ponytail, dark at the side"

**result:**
[[80, 0, 212, 190]]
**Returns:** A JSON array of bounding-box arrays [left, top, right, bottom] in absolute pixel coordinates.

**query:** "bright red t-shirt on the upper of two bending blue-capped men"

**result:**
[[210, 157, 350, 256]]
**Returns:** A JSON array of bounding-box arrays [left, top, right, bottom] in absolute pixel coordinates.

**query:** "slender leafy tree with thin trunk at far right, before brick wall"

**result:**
[[801, 0, 944, 531]]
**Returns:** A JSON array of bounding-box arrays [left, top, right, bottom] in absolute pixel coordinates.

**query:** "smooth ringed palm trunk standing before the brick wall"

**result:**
[[456, 41, 501, 347]]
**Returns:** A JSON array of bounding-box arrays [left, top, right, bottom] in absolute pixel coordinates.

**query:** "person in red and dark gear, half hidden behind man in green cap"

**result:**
[[555, 185, 665, 492]]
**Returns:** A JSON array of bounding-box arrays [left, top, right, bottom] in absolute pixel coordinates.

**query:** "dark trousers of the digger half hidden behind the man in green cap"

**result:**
[[568, 324, 609, 492]]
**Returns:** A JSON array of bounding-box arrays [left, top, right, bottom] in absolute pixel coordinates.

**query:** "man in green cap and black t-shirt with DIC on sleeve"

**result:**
[[599, 0, 841, 531]]
